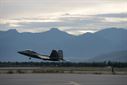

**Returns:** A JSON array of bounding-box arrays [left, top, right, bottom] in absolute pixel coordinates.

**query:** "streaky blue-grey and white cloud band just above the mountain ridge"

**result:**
[[0, 13, 127, 35]]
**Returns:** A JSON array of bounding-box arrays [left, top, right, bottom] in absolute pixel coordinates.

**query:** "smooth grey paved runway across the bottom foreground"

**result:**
[[0, 74, 127, 85]]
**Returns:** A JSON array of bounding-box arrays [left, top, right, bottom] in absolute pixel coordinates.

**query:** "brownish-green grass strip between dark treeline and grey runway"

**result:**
[[0, 67, 127, 75]]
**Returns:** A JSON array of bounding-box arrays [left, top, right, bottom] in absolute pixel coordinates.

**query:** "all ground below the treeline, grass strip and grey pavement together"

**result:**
[[0, 67, 127, 85]]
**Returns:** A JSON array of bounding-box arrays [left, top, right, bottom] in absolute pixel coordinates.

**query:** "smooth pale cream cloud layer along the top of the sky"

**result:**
[[0, 0, 127, 18]]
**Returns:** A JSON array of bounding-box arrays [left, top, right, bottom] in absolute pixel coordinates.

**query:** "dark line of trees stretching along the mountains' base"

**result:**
[[0, 61, 127, 67]]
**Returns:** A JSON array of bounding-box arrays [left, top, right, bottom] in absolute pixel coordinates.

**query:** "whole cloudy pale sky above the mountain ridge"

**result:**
[[0, 0, 127, 35]]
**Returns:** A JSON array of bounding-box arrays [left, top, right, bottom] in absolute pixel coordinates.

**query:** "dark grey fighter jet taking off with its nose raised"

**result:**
[[18, 50, 64, 61]]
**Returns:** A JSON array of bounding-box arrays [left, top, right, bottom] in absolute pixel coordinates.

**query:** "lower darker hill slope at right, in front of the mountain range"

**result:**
[[89, 51, 127, 62]]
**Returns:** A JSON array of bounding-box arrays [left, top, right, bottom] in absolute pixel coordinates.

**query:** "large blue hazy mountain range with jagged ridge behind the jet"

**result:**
[[0, 28, 127, 61]]
